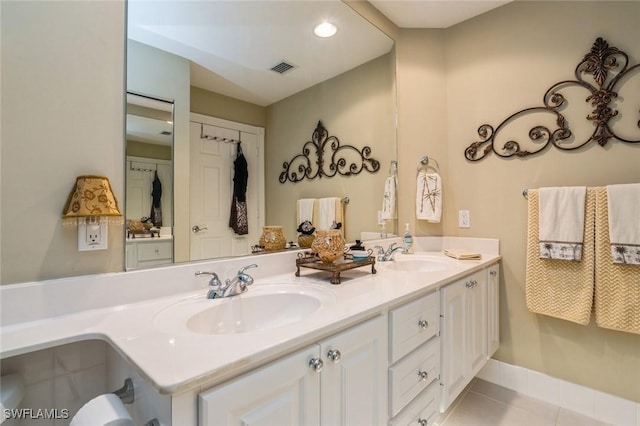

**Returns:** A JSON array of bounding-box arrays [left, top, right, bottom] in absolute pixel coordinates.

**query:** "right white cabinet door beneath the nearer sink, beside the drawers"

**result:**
[[318, 316, 387, 426]]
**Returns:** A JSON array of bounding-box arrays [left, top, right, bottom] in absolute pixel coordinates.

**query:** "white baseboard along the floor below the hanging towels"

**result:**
[[477, 359, 640, 426]]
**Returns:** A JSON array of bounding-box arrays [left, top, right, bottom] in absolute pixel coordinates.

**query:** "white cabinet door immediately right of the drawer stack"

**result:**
[[440, 280, 467, 412]]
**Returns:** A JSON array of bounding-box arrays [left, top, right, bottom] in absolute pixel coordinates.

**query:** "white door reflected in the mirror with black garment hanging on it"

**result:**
[[190, 121, 261, 260]]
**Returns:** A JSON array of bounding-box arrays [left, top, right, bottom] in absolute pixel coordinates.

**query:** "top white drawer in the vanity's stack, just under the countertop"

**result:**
[[389, 291, 440, 364]]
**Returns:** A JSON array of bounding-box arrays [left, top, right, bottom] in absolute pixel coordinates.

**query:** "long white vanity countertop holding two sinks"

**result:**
[[0, 240, 500, 394]]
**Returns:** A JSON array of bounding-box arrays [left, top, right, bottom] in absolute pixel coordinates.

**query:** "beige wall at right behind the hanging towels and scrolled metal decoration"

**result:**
[[397, 2, 640, 401]]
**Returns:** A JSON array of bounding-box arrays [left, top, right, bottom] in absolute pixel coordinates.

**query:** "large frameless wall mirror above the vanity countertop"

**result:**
[[126, 0, 397, 269]]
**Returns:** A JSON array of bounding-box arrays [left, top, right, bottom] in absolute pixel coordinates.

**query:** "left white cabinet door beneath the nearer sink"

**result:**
[[198, 345, 320, 426]]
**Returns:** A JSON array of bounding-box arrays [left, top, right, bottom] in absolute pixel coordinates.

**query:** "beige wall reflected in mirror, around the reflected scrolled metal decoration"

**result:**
[[265, 53, 396, 241]]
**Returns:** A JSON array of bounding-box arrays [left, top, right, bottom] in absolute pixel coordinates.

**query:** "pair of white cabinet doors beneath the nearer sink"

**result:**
[[198, 315, 387, 426]]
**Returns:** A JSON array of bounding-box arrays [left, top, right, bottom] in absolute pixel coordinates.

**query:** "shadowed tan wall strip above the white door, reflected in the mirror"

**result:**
[[191, 86, 267, 127]]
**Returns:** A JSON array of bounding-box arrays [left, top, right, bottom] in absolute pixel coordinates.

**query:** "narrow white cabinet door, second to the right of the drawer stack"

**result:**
[[465, 271, 488, 374]]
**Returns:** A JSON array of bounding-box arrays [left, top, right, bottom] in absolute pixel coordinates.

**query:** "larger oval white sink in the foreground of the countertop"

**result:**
[[154, 284, 335, 335]]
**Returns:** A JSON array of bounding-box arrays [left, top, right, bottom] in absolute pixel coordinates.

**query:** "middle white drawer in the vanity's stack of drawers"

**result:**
[[389, 338, 440, 416]]
